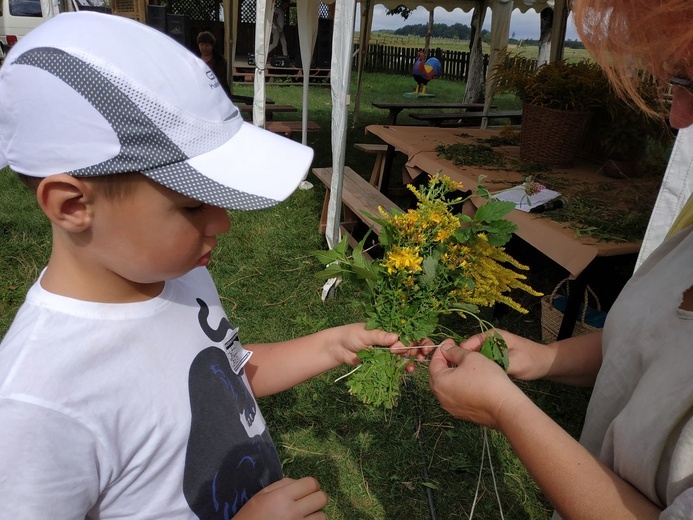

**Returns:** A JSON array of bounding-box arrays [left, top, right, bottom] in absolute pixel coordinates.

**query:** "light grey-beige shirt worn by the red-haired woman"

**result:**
[[554, 227, 693, 520]]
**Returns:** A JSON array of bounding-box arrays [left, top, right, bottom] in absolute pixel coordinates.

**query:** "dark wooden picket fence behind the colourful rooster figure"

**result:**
[[354, 44, 489, 81]]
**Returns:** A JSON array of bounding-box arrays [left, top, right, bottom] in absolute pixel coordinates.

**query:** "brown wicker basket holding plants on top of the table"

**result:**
[[520, 103, 592, 164]]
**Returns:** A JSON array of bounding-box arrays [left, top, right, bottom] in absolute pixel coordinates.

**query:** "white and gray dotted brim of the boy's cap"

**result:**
[[142, 123, 313, 210]]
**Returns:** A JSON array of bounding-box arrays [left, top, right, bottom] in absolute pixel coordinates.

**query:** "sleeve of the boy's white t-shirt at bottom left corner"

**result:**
[[0, 399, 99, 520]]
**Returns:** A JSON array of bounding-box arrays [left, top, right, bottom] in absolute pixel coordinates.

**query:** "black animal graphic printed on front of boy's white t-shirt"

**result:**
[[183, 299, 282, 519]]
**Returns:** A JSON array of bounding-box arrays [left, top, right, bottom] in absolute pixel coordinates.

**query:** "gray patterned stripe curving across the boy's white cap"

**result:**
[[13, 47, 279, 209]]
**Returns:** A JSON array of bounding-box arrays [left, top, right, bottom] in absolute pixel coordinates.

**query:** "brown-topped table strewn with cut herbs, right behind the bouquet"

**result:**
[[366, 125, 641, 339]]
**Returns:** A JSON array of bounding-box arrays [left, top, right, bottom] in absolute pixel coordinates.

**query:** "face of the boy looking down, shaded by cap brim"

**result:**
[[90, 175, 231, 284]]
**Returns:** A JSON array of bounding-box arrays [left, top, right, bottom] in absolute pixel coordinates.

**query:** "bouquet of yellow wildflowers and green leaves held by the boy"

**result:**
[[315, 174, 541, 408]]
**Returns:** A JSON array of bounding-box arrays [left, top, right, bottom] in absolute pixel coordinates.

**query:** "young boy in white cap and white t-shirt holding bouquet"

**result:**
[[0, 13, 409, 520]]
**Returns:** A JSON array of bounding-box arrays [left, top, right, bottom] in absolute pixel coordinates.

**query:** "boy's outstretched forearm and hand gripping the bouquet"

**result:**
[[245, 323, 397, 397]]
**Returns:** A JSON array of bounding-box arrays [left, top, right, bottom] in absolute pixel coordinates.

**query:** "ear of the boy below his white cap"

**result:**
[[36, 173, 93, 233]]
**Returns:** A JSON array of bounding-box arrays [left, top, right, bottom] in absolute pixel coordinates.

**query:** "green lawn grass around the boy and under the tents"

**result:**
[[0, 70, 612, 520]]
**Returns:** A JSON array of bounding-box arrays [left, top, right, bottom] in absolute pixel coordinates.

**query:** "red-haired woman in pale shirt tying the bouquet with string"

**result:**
[[429, 0, 693, 520]]
